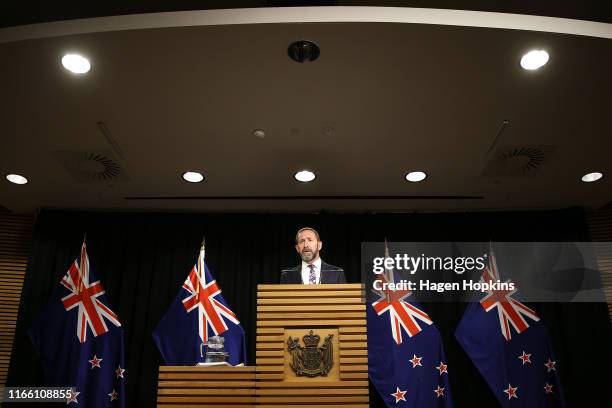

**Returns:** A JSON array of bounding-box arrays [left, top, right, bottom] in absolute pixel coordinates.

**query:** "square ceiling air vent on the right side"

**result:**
[[482, 146, 555, 177]]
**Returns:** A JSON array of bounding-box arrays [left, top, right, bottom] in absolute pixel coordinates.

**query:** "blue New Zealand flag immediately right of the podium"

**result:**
[[367, 251, 453, 408]]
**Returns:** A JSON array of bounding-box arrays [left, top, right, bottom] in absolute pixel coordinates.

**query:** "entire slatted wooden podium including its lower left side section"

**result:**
[[157, 284, 368, 408]]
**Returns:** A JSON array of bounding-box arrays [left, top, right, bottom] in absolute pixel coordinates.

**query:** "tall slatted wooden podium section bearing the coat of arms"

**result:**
[[255, 284, 368, 408]]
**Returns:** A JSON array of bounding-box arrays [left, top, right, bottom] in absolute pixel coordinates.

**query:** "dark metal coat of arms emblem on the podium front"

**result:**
[[287, 330, 334, 377]]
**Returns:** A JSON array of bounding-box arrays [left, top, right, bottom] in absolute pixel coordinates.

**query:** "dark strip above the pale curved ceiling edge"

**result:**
[[0, 0, 612, 27]]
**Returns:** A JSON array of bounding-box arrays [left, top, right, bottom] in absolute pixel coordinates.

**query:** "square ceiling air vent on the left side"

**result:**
[[54, 150, 129, 183]]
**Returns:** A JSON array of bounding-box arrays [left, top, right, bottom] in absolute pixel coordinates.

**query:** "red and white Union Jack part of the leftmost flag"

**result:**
[[60, 241, 121, 343]]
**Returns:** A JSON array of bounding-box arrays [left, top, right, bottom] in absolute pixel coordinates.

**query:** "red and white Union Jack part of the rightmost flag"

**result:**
[[480, 251, 540, 341]]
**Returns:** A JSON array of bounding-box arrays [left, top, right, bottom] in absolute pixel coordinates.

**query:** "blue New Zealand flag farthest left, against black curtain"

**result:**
[[29, 242, 126, 408]]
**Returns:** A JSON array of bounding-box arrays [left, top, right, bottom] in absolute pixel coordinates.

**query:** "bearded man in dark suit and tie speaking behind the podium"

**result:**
[[280, 227, 346, 285]]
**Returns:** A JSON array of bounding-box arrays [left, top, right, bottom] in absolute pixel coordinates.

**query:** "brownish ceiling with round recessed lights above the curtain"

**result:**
[[0, 9, 612, 212]]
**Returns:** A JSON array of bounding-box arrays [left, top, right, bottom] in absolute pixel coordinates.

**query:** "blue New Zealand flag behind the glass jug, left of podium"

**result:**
[[153, 249, 246, 365]]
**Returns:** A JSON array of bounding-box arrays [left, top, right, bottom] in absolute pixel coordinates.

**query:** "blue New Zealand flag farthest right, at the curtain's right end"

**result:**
[[455, 253, 565, 408]]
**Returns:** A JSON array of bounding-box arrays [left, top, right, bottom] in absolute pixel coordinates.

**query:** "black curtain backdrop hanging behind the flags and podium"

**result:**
[[7, 209, 612, 407]]
